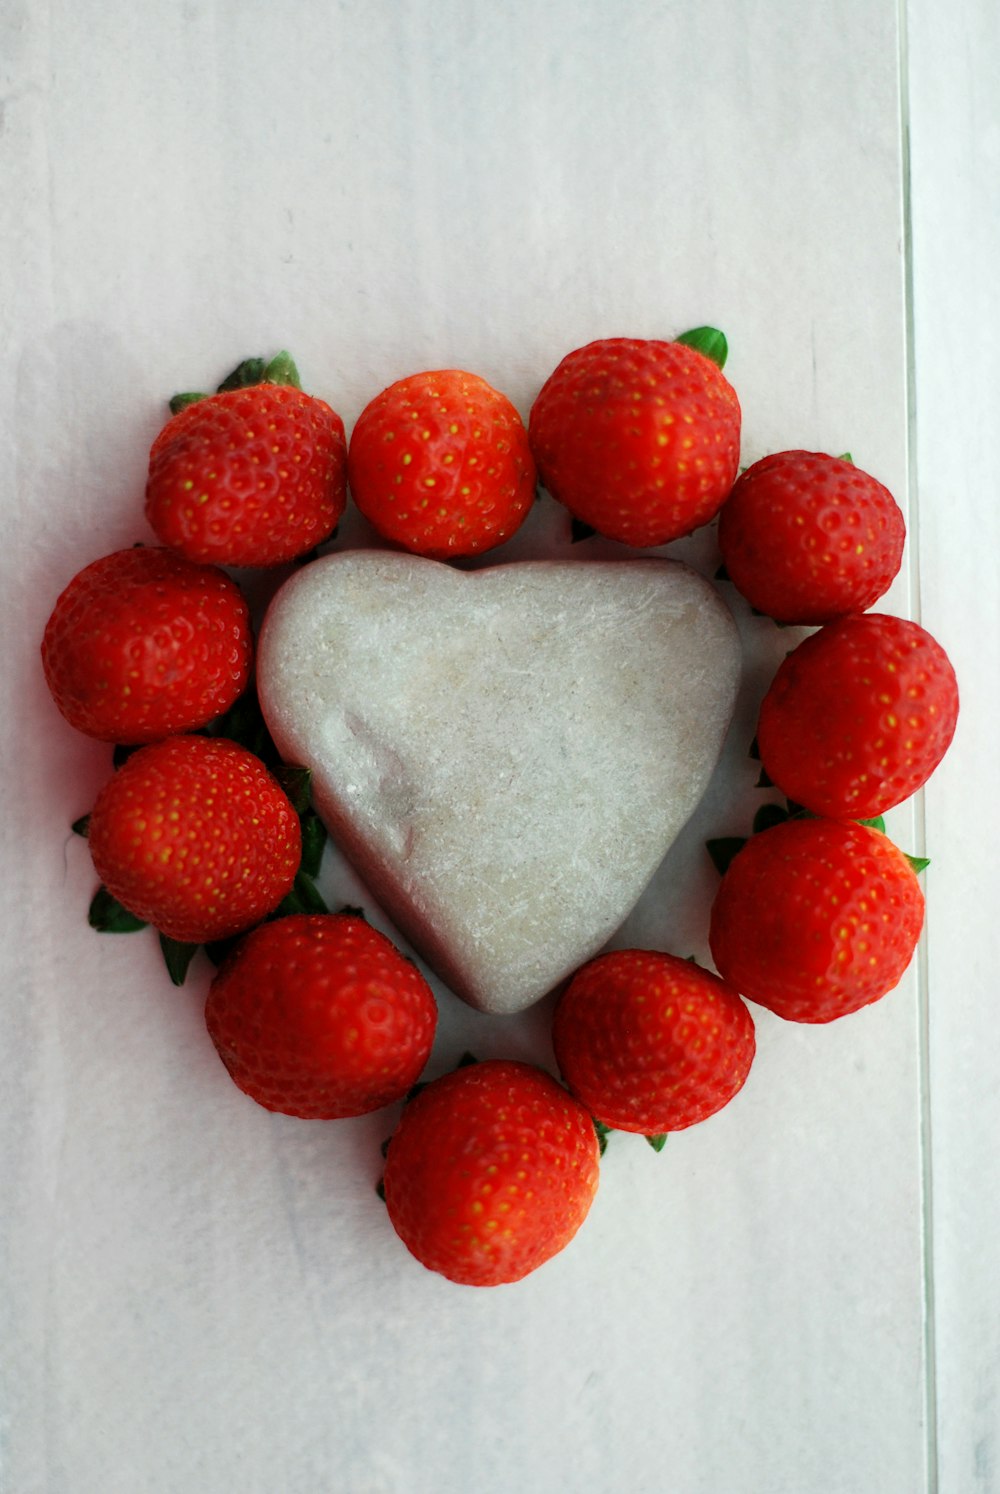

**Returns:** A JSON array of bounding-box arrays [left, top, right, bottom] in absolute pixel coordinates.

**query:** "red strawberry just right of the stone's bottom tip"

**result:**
[[552, 949, 755, 1135]]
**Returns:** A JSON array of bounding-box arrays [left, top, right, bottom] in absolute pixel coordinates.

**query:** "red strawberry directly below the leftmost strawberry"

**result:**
[[88, 737, 302, 944]]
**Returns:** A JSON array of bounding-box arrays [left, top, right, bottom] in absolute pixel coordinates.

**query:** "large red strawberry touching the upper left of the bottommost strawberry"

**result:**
[[205, 913, 438, 1121]]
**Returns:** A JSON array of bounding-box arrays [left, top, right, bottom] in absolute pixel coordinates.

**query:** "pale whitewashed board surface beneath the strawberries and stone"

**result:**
[[0, 0, 1000, 1494]]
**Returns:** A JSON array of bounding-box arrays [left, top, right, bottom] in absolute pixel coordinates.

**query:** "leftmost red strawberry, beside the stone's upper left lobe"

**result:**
[[42, 545, 253, 744]]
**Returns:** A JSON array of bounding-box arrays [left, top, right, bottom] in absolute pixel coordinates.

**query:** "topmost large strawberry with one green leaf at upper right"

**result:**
[[528, 329, 740, 547]]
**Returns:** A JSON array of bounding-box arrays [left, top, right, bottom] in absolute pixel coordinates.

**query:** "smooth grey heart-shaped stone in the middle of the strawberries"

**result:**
[[257, 550, 740, 1013]]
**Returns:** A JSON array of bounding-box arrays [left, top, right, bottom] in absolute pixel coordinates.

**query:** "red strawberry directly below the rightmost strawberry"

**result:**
[[709, 819, 924, 1022]]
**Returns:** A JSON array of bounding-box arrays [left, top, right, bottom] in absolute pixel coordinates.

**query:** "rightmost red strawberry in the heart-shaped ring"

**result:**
[[758, 613, 958, 820]]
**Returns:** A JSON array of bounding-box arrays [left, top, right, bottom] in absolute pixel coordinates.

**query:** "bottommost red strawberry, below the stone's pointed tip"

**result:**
[[384, 1059, 599, 1286]]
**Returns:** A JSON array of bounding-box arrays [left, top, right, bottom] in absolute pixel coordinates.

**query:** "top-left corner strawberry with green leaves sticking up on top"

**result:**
[[146, 353, 347, 566]]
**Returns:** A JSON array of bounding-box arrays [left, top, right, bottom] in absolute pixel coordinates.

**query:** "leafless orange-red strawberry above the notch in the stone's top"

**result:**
[[348, 369, 535, 560]]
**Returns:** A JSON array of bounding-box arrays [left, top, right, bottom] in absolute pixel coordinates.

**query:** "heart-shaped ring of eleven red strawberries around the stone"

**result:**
[[42, 336, 958, 1285]]
